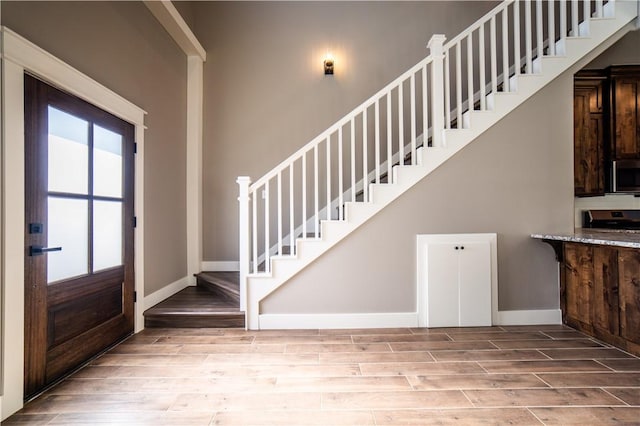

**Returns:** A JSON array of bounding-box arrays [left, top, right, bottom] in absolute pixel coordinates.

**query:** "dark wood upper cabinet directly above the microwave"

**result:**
[[609, 65, 640, 160]]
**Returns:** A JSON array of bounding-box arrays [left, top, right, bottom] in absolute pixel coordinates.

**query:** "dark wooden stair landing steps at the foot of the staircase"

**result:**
[[144, 272, 245, 328]]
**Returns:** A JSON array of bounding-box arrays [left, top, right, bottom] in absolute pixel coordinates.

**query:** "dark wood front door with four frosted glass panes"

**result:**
[[24, 75, 134, 399]]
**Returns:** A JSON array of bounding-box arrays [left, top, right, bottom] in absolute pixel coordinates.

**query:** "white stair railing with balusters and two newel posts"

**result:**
[[238, 0, 614, 308]]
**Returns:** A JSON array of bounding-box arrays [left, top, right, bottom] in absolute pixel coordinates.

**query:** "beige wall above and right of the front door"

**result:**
[[1, 1, 187, 294]]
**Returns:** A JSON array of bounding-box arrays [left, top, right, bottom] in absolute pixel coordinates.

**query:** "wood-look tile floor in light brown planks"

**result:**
[[3, 325, 640, 426]]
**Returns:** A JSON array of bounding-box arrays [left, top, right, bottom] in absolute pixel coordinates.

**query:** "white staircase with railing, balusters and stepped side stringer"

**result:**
[[238, 0, 638, 329]]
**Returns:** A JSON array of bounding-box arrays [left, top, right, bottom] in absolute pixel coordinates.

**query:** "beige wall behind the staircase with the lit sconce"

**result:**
[[192, 1, 496, 261]]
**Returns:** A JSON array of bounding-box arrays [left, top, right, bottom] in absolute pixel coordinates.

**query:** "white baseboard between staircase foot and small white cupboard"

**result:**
[[259, 312, 418, 330]]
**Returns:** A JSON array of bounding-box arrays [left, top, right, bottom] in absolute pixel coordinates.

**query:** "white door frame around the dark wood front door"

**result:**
[[0, 27, 146, 420]]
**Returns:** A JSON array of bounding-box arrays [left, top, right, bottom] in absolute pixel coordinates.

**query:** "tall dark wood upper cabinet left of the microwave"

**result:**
[[573, 70, 608, 197]]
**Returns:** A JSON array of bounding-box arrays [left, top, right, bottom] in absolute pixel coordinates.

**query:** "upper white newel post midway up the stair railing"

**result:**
[[427, 34, 447, 146]]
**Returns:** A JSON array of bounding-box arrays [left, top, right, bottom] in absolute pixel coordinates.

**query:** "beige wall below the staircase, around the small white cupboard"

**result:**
[[261, 73, 573, 314]]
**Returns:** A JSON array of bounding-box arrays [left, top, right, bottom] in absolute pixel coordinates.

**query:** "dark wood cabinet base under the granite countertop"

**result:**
[[560, 243, 640, 355]]
